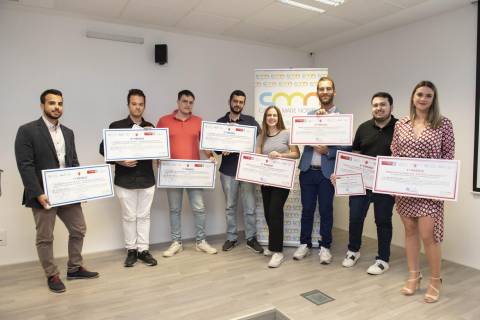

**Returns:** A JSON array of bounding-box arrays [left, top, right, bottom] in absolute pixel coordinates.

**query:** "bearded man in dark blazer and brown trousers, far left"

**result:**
[[15, 89, 98, 293]]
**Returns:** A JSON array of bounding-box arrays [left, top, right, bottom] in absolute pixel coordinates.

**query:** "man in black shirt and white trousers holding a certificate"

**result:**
[[100, 89, 157, 267]]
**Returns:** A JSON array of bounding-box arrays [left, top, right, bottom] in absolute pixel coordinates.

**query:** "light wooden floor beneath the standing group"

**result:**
[[0, 230, 480, 320]]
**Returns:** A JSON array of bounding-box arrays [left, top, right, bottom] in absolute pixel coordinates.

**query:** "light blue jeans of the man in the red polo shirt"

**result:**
[[167, 188, 206, 241]]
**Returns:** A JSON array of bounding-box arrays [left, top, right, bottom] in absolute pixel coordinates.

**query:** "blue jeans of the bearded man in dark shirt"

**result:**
[[220, 173, 257, 241]]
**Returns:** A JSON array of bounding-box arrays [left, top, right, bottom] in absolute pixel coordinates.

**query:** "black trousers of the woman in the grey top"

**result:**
[[261, 186, 290, 252]]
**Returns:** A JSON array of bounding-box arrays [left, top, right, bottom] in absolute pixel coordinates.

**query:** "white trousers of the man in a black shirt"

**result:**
[[115, 186, 155, 252]]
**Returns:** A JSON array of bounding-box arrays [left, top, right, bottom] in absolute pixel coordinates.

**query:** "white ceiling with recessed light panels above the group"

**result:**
[[0, 0, 473, 52]]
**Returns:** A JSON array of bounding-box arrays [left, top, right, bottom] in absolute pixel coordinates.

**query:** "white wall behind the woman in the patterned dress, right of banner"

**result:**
[[316, 5, 480, 269]]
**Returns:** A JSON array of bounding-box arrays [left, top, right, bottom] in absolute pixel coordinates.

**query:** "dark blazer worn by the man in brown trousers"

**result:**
[[15, 118, 79, 208]]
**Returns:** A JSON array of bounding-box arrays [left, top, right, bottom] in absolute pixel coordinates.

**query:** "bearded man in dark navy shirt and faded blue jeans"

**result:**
[[217, 90, 263, 253]]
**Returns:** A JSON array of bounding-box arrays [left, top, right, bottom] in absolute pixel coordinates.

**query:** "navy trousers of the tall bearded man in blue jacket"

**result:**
[[300, 169, 335, 248]]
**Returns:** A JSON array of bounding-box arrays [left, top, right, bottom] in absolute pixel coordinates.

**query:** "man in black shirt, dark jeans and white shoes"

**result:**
[[342, 92, 397, 275]]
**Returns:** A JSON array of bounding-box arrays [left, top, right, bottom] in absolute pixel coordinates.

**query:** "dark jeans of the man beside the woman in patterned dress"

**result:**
[[348, 190, 395, 262]]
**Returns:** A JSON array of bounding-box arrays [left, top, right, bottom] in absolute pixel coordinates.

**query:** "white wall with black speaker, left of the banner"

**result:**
[[0, 7, 312, 265]]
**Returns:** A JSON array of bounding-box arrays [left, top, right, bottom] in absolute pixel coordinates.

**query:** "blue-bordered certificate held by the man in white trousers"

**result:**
[[103, 128, 170, 161]]
